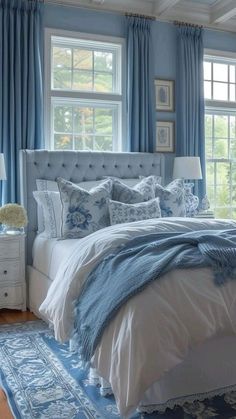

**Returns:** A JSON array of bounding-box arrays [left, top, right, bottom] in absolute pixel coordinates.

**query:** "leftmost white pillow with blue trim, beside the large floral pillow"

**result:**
[[33, 191, 62, 239]]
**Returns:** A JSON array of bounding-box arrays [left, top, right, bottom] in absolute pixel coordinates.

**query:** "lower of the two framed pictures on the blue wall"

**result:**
[[156, 121, 175, 153]]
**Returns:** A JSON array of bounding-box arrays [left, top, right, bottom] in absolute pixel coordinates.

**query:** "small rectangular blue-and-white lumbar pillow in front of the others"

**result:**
[[109, 198, 161, 225]]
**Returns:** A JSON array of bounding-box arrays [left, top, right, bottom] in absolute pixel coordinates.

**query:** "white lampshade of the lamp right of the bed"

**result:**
[[173, 157, 202, 180]]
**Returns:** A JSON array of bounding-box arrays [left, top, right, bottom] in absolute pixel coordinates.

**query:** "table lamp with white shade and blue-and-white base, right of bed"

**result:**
[[173, 156, 202, 217]]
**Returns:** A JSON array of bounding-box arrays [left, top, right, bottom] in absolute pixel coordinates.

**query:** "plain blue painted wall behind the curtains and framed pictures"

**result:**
[[43, 4, 236, 181]]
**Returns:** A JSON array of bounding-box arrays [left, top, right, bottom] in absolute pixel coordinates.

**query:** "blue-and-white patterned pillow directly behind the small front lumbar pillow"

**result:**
[[112, 176, 155, 204]]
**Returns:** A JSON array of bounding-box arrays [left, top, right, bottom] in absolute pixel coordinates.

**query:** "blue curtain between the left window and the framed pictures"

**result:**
[[127, 17, 156, 152]]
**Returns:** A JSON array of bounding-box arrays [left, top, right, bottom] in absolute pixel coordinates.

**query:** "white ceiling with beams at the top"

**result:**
[[48, 0, 236, 32]]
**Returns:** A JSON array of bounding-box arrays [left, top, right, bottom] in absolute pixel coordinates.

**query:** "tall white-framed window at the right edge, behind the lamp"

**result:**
[[204, 52, 236, 218]]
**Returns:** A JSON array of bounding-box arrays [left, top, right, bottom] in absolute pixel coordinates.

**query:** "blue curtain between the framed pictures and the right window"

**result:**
[[176, 26, 206, 199]]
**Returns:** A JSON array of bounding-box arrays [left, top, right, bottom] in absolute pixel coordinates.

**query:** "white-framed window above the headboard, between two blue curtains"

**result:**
[[45, 30, 125, 151]]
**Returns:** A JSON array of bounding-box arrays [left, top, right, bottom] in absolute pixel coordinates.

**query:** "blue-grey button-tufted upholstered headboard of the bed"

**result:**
[[20, 150, 165, 264]]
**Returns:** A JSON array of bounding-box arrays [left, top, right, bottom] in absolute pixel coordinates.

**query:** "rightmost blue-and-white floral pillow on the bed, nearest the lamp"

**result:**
[[155, 179, 186, 217]]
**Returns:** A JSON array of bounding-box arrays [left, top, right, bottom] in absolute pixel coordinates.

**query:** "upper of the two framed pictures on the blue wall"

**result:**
[[155, 79, 174, 112]]
